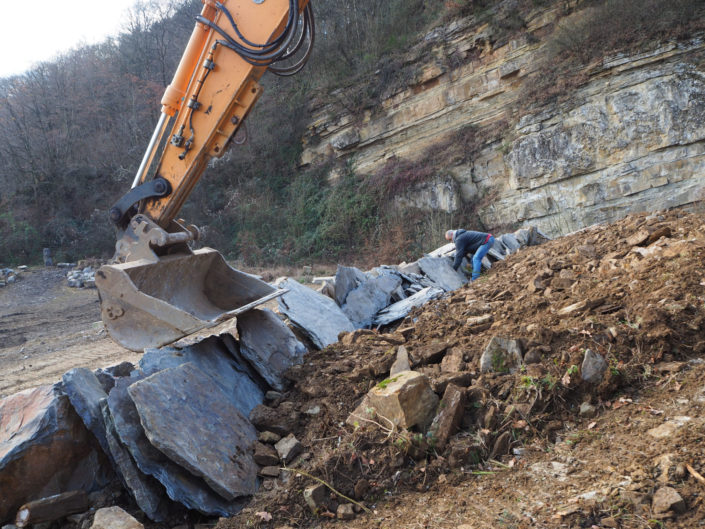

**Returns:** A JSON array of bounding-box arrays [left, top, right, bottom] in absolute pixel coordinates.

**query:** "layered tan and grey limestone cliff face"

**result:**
[[302, 7, 705, 235]]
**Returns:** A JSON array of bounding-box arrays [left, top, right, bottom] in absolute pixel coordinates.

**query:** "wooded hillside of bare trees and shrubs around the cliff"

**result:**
[[0, 0, 704, 265]]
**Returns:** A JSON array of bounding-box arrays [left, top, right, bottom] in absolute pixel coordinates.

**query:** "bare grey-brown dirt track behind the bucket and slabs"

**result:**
[[0, 268, 139, 398]]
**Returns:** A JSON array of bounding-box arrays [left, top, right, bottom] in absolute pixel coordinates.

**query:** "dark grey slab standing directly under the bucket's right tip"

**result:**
[[237, 309, 306, 390]]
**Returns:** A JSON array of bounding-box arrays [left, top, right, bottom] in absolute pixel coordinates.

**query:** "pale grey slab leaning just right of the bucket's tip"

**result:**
[[277, 278, 355, 349]]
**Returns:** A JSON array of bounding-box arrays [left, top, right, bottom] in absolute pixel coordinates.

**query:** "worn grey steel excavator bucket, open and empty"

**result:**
[[96, 248, 286, 351]]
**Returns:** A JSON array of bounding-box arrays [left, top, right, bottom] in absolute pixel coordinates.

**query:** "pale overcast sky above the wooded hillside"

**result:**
[[0, 0, 142, 77]]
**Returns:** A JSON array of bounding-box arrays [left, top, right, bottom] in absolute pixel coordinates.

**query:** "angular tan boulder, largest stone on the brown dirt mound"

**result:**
[[368, 371, 438, 428]]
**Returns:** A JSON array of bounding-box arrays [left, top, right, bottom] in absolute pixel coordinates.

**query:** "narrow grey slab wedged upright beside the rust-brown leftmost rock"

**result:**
[[61, 367, 110, 456]]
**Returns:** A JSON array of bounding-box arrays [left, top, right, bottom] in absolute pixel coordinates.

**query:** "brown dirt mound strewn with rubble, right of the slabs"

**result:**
[[219, 212, 705, 529]]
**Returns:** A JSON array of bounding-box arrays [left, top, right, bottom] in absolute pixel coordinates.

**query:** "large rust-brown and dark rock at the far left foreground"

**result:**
[[0, 386, 114, 524]]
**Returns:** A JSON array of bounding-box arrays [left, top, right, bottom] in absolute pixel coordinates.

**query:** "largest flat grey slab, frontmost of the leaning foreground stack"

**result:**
[[127, 363, 257, 501]]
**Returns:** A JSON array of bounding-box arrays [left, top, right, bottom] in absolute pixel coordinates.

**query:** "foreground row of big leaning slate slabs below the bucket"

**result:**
[[0, 309, 306, 524]]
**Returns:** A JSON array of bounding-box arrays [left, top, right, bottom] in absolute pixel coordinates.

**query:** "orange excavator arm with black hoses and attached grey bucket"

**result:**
[[96, 0, 314, 350]]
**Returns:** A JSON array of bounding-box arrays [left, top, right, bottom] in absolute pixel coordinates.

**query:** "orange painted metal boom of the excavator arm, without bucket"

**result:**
[[140, 0, 308, 228]]
